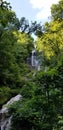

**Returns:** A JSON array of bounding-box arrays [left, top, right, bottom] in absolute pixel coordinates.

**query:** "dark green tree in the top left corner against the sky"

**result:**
[[0, 0, 20, 30]]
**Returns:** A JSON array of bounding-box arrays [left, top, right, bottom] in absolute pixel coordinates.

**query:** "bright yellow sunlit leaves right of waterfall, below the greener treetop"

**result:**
[[37, 21, 63, 59]]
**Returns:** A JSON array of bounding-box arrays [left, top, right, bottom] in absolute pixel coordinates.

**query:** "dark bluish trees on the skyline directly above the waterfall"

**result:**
[[20, 17, 42, 37]]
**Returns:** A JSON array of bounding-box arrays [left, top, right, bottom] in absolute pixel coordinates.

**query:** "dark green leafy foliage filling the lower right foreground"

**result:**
[[10, 69, 63, 130]]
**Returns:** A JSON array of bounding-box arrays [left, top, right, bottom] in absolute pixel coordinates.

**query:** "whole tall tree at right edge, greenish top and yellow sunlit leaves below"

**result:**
[[37, 0, 63, 62]]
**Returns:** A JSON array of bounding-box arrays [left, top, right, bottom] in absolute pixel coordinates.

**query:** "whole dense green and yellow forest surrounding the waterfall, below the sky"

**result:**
[[0, 0, 63, 130]]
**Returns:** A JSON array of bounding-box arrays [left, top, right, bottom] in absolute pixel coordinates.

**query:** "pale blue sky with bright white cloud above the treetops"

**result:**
[[6, 0, 59, 23]]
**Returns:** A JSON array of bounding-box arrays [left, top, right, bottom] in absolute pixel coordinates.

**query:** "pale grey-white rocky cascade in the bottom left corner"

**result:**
[[0, 94, 22, 130]]
